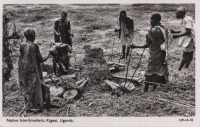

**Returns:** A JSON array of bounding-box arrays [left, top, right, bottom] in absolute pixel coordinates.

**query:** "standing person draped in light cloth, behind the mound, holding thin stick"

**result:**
[[115, 10, 134, 59]]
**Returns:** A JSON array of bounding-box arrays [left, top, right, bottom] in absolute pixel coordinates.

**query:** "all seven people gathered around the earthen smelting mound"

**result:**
[[3, 7, 195, 112]]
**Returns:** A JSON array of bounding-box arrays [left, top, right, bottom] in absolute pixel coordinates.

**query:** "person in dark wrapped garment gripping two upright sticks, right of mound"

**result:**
[[131, 13, 169, 92]]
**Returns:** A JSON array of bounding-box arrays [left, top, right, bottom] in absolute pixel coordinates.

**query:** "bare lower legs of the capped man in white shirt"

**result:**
[[178, 51, 194, 70]]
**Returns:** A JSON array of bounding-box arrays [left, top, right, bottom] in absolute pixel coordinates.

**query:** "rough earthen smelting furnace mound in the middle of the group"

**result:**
[[82, 45, 110, 84]]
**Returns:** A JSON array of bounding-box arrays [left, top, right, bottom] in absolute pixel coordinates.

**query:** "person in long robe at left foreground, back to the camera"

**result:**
[[18, 29, 50, 112]]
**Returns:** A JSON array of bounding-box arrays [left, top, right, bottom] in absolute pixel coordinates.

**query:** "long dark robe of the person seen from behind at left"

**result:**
[[19, 41, 43, 110]]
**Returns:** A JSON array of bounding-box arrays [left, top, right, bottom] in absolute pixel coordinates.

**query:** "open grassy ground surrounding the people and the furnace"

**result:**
[[3, 4, 195, 117]]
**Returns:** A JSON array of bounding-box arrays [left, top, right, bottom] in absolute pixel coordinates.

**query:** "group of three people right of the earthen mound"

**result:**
[[115, 7, 195, 92]]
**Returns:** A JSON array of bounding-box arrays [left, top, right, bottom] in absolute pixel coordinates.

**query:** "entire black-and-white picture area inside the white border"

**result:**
[[2, 3, 196, 120]]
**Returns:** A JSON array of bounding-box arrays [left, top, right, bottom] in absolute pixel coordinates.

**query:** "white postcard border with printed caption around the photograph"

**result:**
[[0, 0, 200, 127]]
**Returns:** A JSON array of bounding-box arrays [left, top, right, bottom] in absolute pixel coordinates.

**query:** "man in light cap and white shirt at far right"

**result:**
[[171, 7, 195, 71]]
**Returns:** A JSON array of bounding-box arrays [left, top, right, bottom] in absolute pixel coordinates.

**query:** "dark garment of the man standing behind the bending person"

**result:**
[[54, 19, 72, 46]]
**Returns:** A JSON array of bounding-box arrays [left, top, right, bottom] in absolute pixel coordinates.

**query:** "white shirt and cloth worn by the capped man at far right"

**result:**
[[179, 16, 195, 48]]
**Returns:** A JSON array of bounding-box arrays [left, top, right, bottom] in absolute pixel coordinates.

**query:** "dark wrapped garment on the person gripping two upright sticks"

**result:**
[[145, 26, 169, 91]]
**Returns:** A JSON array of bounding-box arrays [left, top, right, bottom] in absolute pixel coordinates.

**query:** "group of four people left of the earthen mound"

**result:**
[[3, 12, 73, 112]]
